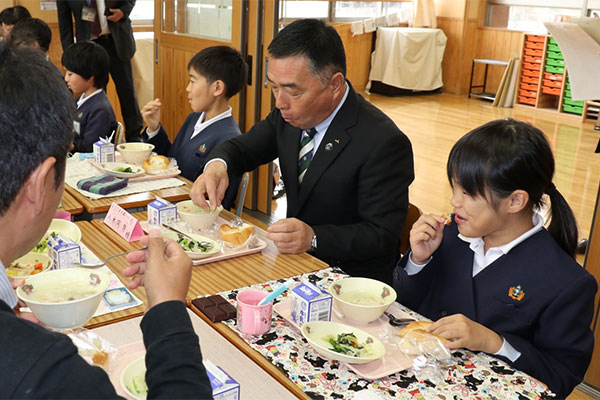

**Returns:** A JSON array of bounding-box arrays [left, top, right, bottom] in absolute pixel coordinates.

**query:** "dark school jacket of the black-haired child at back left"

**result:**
[[73, 91, 117, 153]]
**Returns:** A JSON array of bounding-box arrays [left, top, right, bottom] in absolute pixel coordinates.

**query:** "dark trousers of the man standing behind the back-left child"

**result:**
[[94, 35, 144, 142]]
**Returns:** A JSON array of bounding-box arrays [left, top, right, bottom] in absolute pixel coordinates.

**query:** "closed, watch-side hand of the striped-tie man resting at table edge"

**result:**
[[267, 218, 315, 253]]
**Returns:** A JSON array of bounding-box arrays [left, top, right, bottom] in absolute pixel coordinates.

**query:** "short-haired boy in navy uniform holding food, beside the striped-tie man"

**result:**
[[142, 46, 248, 209]]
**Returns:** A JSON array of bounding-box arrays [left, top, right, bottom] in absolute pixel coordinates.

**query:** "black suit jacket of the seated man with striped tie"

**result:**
[[209, 83, 414, 283]]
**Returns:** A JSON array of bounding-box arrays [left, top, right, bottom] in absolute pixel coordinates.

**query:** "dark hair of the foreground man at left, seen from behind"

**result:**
[[0, 43, 75, 216]]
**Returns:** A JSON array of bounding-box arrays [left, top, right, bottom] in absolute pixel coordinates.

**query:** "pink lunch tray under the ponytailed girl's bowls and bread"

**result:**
[[273, 299, 413, 380]]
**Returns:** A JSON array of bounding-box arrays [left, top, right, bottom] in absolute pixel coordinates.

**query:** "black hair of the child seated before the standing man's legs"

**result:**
[[62, 42, 110, 89]]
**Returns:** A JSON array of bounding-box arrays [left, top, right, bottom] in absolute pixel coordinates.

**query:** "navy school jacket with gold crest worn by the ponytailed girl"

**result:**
[[394, 224, 597, 399]]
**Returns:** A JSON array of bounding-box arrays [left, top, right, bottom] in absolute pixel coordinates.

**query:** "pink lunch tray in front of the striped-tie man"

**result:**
[[140, 217, 267, 265]]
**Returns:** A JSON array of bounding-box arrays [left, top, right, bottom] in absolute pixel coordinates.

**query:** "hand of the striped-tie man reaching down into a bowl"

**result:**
[[190, 161, 229, 211]]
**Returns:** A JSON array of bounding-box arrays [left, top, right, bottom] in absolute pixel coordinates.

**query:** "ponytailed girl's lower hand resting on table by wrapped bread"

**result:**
[[427, 314, 504, 354]]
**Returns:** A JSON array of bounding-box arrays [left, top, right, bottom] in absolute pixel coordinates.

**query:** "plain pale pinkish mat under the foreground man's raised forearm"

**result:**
[[94, 310, 295, 400]]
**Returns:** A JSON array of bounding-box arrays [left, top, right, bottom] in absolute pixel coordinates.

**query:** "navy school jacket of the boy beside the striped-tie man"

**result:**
[[149, 113, 241, 209]]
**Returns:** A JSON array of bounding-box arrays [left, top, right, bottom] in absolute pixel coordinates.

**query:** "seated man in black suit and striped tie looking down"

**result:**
[[191, 20, 414, 282]]
